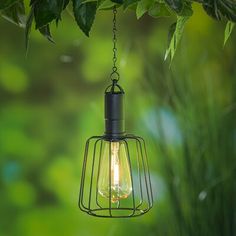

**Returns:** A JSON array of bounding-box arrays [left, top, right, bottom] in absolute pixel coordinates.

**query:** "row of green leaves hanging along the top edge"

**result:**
[[0, 0, 236, 59]]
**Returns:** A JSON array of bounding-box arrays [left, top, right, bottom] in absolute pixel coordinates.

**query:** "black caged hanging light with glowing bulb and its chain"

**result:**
[[79, 7, 153, 218]]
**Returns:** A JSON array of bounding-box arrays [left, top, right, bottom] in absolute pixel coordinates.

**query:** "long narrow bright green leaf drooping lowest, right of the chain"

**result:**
[[165, 16, 189, 62]]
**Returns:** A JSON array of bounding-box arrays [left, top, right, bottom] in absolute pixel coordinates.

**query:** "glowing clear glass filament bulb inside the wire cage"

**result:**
[[98, 141, 132, 203]]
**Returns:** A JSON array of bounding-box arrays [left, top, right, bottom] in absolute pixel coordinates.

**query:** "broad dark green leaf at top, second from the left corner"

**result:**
[[34, 0, 65, 29]]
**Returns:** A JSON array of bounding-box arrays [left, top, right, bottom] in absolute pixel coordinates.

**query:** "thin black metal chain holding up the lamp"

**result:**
[[110, 6, 120, 84]]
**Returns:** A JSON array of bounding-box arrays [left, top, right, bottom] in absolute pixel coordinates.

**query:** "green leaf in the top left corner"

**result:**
[[1, 0, 25, 27]]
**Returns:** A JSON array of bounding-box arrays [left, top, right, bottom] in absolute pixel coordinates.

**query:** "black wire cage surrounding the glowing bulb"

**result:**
[[78, 134, 153, 218]]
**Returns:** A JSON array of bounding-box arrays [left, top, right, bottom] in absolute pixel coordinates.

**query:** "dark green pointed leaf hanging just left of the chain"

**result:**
[[73, 0, 97, 37]]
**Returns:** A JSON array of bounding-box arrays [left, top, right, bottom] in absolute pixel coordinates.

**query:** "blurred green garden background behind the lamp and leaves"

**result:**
[[0, 6, 236, 236]]
